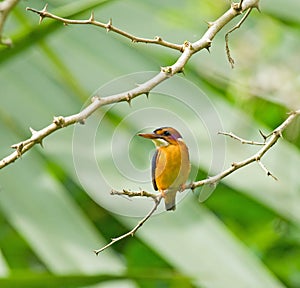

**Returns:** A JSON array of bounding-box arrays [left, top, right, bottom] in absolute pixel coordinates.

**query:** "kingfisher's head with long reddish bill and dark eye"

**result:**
[[138, 127, 182, 147]]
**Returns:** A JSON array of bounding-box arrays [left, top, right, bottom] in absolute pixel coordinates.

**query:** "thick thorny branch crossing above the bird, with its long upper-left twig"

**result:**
[[0, 0, 258, 169]]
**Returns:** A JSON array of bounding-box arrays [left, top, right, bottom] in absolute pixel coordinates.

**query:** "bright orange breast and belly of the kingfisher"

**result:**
[[154, 142, 190, 191]]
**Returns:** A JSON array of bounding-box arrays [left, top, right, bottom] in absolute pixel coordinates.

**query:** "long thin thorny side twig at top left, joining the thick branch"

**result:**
[[26, 4, 183, 52]]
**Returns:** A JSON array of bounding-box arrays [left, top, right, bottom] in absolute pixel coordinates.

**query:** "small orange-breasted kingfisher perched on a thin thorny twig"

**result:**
[[138, 127, 191, 210]]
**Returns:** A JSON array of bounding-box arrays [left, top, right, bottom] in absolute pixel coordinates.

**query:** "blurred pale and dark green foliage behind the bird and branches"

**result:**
[[0, 0, 300, 288]]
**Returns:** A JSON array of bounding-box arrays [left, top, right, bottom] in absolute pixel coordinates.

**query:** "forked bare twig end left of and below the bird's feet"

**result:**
[[94, 191, 163, 255]]
